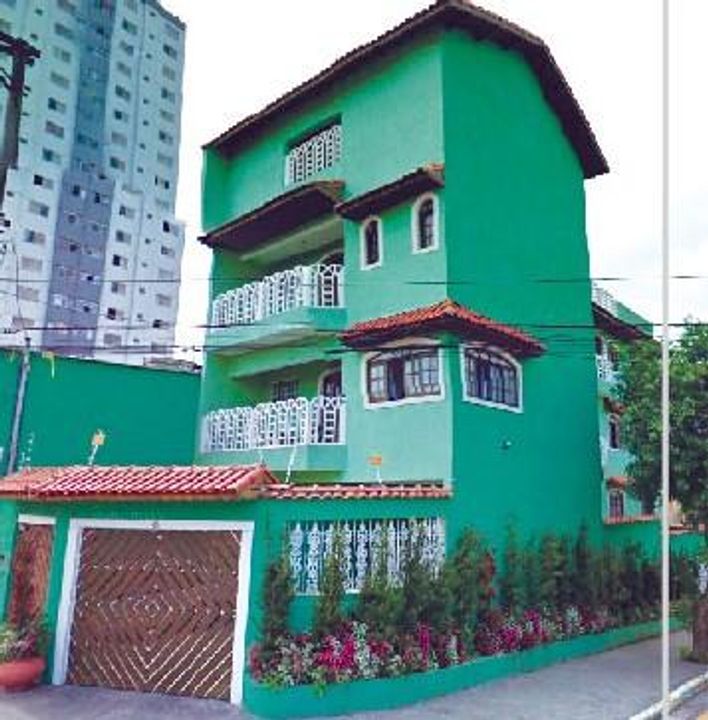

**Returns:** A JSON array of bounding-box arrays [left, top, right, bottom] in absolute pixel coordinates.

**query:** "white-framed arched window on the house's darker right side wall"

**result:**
[[463, 347, 521, 410]]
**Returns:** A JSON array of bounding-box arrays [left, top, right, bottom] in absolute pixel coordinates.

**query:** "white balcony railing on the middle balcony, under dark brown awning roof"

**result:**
[[211, 265, 344, 326]]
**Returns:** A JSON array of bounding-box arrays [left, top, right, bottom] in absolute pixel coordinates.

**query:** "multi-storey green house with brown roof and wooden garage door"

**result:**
[[0, 0, 668, 716]]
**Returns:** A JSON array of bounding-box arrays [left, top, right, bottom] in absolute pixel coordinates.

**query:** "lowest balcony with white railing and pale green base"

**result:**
[[201, 396, 346, 470]]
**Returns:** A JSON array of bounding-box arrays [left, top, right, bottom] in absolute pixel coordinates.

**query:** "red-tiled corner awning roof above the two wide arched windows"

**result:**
[[341, 300, 544, 356]]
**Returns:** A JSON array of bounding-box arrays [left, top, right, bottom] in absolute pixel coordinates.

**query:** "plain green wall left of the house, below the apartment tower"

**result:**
[[0, 351, 199, 475]]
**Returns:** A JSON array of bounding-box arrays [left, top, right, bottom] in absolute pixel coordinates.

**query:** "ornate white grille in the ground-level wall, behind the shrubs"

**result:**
[[288, 518, 445, 595]]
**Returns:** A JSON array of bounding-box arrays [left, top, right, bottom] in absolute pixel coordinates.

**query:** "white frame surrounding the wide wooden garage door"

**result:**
[[52, 518, 255, 705]]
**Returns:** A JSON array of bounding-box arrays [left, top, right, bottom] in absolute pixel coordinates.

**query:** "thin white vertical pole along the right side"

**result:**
[[661, 0, 670, 720]]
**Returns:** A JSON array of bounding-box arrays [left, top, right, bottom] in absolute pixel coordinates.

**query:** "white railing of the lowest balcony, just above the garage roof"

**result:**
[[202, 396, 345, 452]]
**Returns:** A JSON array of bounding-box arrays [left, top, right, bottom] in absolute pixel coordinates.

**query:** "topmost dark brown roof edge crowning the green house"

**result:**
[[205, 0, 609, 178]]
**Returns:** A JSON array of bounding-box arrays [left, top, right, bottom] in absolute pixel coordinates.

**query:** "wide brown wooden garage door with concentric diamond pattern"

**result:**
[[67, 530, 241, 699]]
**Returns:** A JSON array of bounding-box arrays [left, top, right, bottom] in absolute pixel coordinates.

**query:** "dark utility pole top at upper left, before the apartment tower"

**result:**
[[0, 32, 40, 208]]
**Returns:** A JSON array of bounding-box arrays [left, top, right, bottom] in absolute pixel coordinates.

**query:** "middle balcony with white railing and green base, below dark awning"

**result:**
[[211, 264, 344, 347]]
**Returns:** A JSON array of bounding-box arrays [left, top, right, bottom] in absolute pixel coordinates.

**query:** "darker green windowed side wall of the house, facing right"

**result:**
[[436, 32, 601, 544]]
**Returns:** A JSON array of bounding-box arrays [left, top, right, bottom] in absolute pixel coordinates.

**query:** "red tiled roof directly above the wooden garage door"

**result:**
[[0, 465, 278, 500]]
